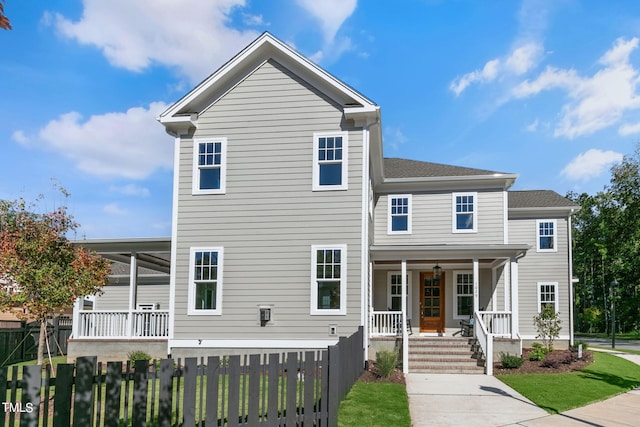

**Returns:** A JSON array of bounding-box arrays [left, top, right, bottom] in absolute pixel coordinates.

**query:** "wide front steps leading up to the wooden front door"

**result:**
[[409, 337, 484, 374]]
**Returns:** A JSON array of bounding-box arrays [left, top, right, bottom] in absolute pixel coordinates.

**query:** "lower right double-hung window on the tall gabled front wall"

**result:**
[[311, 245, 347, 315]]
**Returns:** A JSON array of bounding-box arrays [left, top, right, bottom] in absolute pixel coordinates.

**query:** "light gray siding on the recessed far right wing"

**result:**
[[509, 218, 570, 338]]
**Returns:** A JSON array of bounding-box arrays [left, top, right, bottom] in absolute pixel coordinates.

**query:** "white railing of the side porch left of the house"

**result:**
[[75, 310, 169, 338]]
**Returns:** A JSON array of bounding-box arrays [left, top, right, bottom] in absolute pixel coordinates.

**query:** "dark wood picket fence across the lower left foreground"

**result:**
[[0, 327, 364, 427]]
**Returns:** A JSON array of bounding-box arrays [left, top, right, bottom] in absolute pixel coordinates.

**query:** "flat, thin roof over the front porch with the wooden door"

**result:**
[[369, 244, 532, 261]]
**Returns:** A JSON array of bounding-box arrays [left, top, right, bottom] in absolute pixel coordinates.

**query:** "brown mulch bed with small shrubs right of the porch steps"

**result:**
[[493, 348, 593, 375]]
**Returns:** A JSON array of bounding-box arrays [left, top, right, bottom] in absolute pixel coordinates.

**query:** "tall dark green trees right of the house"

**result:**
[[569, 145, 640, 332]]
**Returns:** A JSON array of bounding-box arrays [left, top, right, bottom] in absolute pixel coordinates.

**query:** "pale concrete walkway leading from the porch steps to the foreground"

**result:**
[[406, 352, 640, 427]]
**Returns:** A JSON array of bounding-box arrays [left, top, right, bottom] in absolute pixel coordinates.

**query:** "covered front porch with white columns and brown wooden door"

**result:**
[[368, 245, 530, 372]]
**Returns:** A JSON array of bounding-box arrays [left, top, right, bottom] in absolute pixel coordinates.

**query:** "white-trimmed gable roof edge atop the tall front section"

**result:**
[[157, 32, 380, 133]]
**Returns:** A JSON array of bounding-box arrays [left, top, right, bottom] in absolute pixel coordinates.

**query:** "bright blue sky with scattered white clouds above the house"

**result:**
[[0, 0, 640, 238]]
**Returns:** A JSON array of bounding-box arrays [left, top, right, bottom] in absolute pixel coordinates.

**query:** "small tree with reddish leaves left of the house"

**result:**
[[0, 194, 110, 364]]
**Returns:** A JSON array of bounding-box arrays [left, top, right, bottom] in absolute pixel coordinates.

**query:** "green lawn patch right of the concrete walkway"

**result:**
[[496, 352, 640, 414]]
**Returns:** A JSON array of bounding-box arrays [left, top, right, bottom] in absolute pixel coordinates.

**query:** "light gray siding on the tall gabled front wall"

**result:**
[[174, 61, 363, 340]]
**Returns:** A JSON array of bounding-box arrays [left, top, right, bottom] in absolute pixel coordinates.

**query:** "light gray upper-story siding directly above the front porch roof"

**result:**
[[375, 191, 504, 245]]
